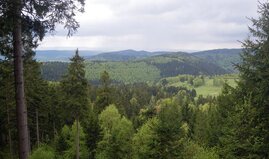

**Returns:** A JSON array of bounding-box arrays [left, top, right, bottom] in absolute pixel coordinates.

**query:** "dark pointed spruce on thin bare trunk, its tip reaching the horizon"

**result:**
[[61, 50, 88, 158]]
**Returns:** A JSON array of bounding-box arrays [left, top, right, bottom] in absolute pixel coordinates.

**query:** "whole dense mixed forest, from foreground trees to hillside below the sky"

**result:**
[[0, 0, 269, 159]]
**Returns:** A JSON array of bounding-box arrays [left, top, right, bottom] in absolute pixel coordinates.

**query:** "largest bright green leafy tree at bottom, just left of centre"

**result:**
[[96, 105, 133, 159]]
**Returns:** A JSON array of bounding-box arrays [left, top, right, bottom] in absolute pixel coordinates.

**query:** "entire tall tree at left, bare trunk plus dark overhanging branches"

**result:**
[[0, 0, 84, 158]]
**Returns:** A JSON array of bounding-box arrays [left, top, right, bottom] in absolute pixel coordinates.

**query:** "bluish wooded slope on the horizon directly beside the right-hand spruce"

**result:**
[[192, 49, 242, 72]]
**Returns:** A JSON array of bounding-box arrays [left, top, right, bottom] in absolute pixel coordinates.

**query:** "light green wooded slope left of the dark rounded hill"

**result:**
[[86, 61, 160, 83]]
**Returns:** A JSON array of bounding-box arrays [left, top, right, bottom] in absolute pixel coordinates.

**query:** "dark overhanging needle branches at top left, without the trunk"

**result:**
[[0, 0, 84, 55]]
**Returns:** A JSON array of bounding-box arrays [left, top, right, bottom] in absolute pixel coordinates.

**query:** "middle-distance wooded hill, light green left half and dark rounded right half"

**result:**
[[42, 52, 229, 83]]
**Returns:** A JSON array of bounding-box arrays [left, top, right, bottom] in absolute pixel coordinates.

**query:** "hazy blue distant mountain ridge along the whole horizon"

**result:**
[[36, 49, 242, 73]]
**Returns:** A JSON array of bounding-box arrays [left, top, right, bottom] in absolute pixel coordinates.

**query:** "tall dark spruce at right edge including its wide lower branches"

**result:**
[[219, 2, 269, 159]]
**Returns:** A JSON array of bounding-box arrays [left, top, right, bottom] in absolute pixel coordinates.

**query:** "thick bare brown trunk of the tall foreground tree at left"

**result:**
[[13, 0, 29, 159]]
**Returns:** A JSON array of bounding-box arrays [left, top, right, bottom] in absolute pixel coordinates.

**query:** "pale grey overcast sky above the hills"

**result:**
[[38, 0, 258, 51]]
